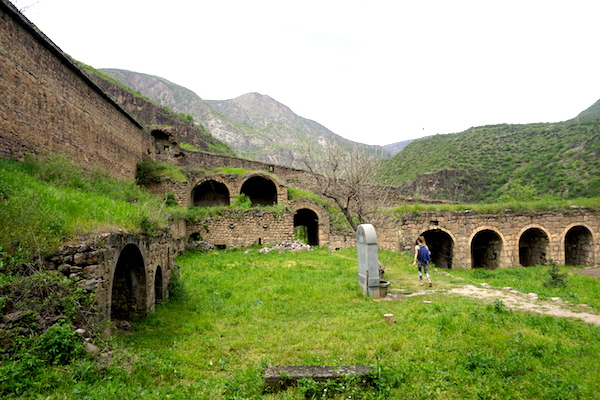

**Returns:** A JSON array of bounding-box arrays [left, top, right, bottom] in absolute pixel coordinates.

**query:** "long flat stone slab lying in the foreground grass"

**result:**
[[264, 365, 374, 391]]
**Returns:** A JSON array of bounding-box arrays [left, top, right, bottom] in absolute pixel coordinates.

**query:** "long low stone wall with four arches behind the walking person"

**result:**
[[374, 208, 600, 269]]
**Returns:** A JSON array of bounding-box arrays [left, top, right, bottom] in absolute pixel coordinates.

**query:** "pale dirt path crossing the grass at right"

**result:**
[[388, 269, 600, 326]]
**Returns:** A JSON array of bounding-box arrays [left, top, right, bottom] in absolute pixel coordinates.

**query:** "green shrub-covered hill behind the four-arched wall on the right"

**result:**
[[384, 119, 600, 201]]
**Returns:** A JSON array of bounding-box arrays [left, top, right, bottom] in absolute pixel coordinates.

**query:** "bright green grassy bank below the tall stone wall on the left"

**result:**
[[0, 156, 179, 264]]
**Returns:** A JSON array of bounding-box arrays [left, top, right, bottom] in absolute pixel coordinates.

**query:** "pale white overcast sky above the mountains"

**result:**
[[13, 0, 600, 145]]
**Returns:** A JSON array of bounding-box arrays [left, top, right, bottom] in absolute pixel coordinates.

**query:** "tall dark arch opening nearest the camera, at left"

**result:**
[[110, 244, 147, 320]]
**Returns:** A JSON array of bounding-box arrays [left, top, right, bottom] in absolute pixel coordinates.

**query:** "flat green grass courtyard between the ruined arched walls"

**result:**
[[0, 249, 600, 400]]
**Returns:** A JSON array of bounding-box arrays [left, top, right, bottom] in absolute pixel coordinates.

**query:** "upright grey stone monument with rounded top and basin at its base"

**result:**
[[356, 224, 389, 299]]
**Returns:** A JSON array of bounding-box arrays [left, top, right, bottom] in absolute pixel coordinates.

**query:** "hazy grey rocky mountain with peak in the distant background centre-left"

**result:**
[[101, 69, 390, 168]]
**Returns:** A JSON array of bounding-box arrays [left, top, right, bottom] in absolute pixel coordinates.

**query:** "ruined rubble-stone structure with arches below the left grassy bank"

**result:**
[[46, 232, 184, 321]]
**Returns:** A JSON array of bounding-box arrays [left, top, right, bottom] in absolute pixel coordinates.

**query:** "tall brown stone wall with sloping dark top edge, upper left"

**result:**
[[0, 0, 153, 179]]
